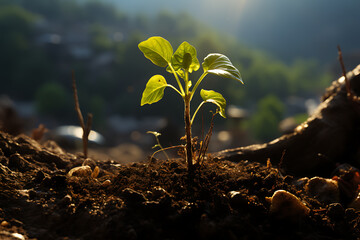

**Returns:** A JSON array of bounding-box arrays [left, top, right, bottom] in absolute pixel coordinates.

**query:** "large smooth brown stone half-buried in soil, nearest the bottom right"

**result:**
[[267, 190, 310, 221]]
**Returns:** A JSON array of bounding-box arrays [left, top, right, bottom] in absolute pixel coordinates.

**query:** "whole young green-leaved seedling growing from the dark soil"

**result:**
[[138, 37, 243, 173]]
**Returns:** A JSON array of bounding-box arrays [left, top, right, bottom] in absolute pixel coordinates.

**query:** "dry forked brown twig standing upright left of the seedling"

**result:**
[[72, 71, 93, 158]]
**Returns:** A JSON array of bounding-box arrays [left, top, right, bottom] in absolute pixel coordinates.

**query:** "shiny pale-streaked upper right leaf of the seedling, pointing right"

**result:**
[[202, 53, 244, 84]]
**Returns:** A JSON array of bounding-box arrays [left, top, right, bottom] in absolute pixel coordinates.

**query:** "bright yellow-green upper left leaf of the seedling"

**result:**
[[138, 37, 173, 67]]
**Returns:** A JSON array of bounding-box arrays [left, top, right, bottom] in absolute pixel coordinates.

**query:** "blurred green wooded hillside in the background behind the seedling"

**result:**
[[0, 0, 352, 145]]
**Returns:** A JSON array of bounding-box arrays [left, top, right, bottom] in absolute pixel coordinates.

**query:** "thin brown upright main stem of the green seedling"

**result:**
[[184, 94, 193, 174]]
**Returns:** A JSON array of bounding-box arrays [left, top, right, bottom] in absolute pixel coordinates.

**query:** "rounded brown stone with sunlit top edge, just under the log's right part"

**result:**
[[305, 177, 340, 203]]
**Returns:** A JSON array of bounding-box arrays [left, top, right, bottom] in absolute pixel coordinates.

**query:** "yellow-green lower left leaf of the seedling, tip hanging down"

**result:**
[[141, 75, 167, 106]]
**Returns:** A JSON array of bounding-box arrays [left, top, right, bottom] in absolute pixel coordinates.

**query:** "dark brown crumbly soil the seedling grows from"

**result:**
[[0, 132, 360, 239]]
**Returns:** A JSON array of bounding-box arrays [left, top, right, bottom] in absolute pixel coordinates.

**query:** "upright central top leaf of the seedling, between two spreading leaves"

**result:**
[[171, 42, 200, 73]]
